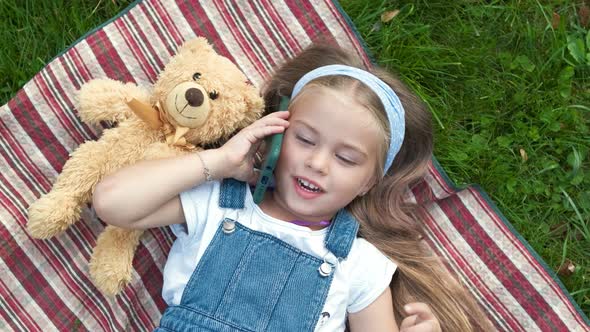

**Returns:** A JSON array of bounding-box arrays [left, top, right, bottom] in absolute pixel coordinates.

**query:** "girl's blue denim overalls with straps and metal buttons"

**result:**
[[156, 179, 358, 331]]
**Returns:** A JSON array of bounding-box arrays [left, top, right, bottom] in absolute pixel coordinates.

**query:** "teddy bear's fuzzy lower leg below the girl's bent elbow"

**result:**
[[90, 226, 143, 296]]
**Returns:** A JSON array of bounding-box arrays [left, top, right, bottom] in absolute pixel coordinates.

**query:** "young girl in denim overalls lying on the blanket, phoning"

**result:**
[[93, 46, 490, 331]]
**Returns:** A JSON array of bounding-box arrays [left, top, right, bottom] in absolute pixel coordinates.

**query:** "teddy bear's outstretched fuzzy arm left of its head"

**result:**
[[78, 78, 149, 125]]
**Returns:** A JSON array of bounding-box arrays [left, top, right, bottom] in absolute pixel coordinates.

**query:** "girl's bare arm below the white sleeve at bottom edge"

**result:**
[[348, 287, 398, 332]]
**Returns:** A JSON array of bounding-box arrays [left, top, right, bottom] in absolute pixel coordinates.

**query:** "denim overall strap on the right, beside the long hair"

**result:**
[[326, 209, 359, 260]]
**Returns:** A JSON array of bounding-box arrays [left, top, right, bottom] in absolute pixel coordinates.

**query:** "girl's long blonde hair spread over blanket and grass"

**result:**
[[263, 45, 493, 331]]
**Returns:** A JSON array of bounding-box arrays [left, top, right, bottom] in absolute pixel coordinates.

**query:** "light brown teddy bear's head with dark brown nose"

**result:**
[[143, 37, 263, 145]]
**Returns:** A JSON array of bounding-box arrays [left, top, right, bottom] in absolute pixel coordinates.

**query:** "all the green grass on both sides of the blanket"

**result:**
[[0, 0, 590, 315]]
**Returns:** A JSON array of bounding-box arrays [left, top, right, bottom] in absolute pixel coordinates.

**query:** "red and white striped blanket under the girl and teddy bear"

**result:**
[[0, 0, 590, 331]]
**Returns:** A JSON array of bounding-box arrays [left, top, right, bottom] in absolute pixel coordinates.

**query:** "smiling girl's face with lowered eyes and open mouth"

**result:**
[[273, 86, 383, 221]]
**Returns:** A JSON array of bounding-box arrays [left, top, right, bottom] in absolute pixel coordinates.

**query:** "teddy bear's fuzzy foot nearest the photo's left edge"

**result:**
[[27, 193, 82, 239]]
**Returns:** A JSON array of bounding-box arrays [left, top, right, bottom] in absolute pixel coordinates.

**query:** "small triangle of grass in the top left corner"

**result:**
[[0, 0, 133, 105]]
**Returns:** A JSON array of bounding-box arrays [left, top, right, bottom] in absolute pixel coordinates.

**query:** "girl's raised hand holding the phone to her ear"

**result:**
[[219, 111, 289, 182]]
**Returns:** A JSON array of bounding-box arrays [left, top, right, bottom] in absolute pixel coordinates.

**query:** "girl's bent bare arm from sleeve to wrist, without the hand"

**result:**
[[92, 149, 225, 229]]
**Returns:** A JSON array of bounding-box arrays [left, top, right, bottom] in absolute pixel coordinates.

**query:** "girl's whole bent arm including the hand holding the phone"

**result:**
[[92, 112, 289, 229]]
